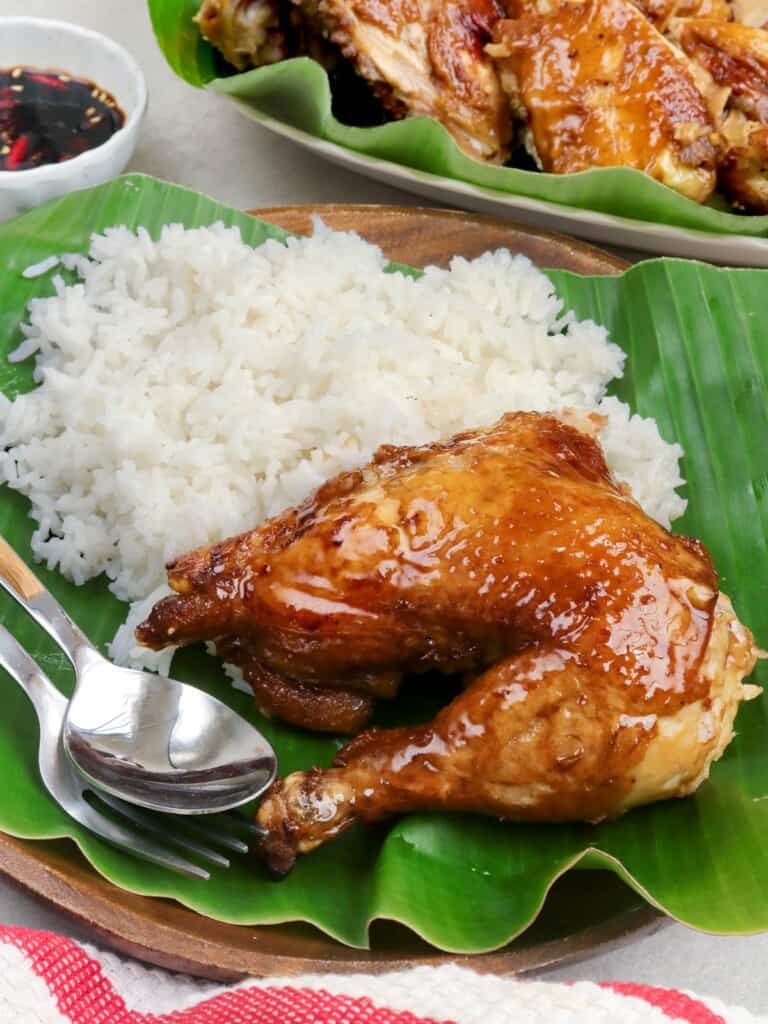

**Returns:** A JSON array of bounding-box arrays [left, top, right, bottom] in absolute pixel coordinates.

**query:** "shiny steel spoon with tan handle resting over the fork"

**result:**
[[0, 538, 278, 814]]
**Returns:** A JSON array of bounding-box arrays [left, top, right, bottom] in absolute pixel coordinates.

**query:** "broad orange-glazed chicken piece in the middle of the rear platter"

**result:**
[[486, 0, 717, 203]]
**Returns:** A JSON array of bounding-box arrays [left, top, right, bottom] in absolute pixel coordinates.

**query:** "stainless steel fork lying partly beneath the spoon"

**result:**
[[0, 626, 262, 880]]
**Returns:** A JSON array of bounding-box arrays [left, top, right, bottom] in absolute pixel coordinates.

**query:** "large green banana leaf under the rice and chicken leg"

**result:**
[[0, 175, 768, 952]]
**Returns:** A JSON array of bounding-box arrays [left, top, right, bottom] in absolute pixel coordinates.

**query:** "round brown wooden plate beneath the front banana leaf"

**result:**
[[0, 206, 662, 980]]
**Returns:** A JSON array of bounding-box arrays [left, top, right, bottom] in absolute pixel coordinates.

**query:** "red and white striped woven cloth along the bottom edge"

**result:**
[[0, 926, 768, 1024]]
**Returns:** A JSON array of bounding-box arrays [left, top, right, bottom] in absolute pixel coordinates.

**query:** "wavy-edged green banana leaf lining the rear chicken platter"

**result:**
[[147, 0, 768, 238]]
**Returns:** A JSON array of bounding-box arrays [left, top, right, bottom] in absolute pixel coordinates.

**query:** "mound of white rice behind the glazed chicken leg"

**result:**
[[0, 223, 685, 671]]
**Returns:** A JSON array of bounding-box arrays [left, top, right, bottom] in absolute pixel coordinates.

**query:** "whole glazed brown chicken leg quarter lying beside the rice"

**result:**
[[137, 413, 755, 873]]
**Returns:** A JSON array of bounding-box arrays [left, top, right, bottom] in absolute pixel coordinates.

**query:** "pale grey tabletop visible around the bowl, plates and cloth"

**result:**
[[0, 0, 768, 1013]]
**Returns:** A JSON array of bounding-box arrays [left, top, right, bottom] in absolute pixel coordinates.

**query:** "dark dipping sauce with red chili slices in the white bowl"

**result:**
[[0, 68, 125, 171]]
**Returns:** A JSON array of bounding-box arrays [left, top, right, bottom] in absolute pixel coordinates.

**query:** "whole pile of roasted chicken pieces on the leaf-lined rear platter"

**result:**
[[197, 0, 768, 213]]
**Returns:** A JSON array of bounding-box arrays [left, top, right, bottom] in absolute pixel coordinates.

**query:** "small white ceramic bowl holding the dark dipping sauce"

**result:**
[[0, 17, 146, 220]]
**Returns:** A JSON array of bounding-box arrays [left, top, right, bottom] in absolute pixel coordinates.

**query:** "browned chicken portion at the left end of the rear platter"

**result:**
[[197, 0, 512, 163]]
